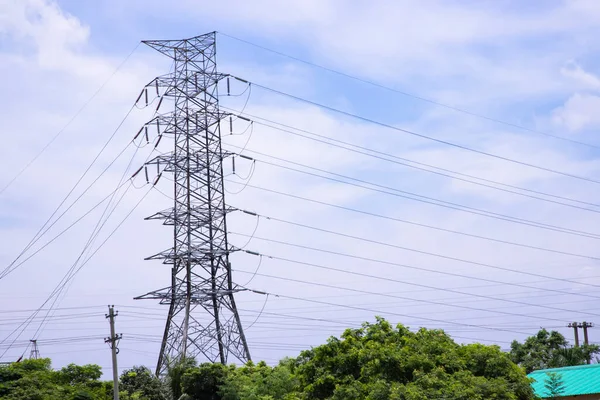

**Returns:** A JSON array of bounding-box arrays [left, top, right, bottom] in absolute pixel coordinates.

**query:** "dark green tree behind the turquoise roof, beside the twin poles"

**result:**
[[510, 329, 600, 373]]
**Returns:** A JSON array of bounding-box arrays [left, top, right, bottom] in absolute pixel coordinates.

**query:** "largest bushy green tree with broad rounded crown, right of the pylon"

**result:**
[[292, 318, 534, 400]]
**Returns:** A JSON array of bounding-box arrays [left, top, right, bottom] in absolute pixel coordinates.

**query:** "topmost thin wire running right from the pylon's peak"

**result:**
[[218, 32, 600, 149]]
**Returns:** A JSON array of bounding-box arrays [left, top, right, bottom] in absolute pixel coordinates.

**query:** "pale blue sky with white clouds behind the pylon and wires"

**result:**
[[0, 0, 600, 374]]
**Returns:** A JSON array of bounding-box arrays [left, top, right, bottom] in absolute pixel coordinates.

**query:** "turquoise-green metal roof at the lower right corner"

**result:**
[[528, 364, 600, 398]]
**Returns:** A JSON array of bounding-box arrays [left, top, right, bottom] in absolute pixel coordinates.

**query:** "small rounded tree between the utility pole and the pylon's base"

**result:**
[[119, 366, 166, 400]]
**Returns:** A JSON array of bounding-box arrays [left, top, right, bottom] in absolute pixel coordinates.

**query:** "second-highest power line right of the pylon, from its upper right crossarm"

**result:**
[[235, 77, 600, 184]]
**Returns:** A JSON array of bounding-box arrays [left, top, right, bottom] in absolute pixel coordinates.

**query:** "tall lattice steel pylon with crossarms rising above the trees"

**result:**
[[137, 33, 250, 374]]
